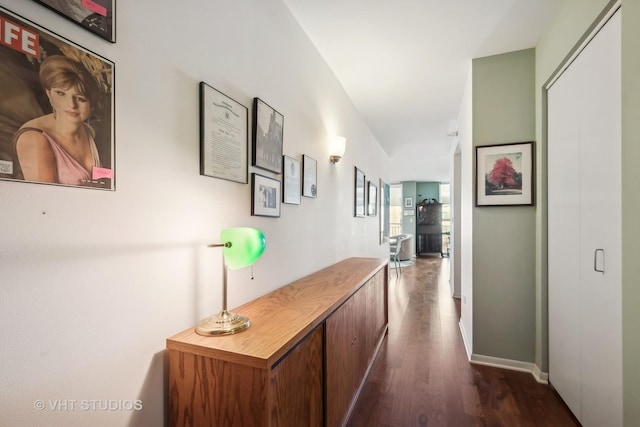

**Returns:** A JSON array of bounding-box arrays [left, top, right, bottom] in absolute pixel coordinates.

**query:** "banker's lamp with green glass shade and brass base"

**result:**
[[196, 227, 266, 336]]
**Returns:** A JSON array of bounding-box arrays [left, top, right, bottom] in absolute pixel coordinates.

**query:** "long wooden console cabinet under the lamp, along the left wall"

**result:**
[[167, 258, 389, 427]]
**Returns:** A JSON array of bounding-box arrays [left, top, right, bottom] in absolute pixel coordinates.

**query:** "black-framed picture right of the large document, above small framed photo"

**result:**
[[251, 98, 284, 173]]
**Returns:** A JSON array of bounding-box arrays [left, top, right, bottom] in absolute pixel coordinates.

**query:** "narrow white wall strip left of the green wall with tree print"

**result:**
[[458, 63, 474, 358]]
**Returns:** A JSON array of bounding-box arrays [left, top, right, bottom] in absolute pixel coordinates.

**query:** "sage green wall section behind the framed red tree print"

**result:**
[[472, 49, 536, 362]]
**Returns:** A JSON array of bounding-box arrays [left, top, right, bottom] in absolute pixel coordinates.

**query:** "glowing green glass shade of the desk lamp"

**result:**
[[220, 227, 267, 270]]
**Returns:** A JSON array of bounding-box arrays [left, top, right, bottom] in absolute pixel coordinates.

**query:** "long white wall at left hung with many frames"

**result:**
[[0, 0, 389, 426]]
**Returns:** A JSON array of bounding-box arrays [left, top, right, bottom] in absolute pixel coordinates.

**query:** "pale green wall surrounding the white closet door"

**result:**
[[536, 0, 640, 426]]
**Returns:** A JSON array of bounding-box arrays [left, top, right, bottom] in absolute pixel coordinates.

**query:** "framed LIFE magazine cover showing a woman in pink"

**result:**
[[0, 8, 116, 190]]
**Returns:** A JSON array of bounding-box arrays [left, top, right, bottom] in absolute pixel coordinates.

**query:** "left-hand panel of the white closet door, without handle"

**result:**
[[547, 58, 581, 420]]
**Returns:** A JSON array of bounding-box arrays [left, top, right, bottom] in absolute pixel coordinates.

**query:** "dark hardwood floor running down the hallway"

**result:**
[[347, 257, 580, 427]]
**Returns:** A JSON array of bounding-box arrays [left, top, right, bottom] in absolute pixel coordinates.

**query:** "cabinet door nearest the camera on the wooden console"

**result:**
[[270, 327, 324, 427]]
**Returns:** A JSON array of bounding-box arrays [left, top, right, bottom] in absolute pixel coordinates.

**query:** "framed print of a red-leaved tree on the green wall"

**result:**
[[476, 142, 534, 206]]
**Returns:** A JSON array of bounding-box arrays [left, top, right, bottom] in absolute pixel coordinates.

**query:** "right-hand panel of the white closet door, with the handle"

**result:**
[[572, 12, 622, 426]]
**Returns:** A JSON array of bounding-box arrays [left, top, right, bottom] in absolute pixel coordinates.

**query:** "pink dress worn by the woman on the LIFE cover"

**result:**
[[14, 128, 100, 185]]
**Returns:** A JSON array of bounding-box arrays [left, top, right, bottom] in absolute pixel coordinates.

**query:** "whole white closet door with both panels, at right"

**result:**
[[548, 7, 622, 427]]
